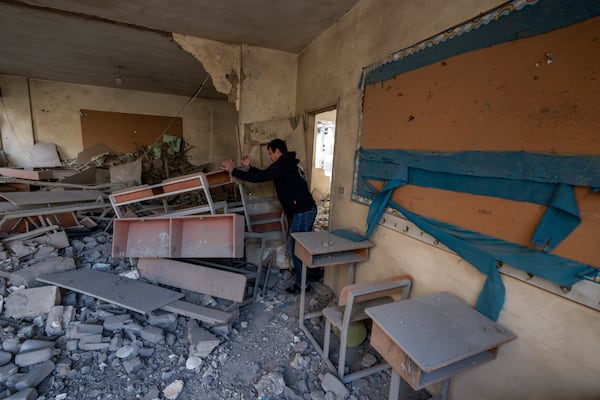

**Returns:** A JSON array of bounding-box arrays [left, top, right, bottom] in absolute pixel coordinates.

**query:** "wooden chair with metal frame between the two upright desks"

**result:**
[[323, 275, 412, 383]]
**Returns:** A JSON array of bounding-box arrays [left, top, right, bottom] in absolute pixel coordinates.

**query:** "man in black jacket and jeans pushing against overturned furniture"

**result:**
[[221, 139, 317, 294]]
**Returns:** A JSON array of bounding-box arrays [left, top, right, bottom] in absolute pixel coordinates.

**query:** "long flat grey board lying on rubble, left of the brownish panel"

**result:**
[[37, 269, 184, 314]]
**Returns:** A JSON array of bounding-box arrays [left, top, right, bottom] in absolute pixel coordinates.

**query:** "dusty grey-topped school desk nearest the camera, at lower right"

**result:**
[[365, 292, 516, 400]]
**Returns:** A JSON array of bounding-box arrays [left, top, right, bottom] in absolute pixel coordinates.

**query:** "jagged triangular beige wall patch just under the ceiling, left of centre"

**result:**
[[173, 33, 241, 110]]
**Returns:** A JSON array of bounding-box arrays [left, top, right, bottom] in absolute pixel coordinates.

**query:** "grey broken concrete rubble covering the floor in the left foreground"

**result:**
[[0, 225, 436, 400]]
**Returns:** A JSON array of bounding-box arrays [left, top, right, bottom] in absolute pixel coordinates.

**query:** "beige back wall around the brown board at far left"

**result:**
[[0, 77, 237, 166]]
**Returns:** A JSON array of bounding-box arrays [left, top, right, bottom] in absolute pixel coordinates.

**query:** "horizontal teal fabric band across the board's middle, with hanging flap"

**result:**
[[357, 150, 600, 251]]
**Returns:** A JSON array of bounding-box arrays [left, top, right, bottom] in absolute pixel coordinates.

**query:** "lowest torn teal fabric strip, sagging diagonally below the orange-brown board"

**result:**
[[342, 156, 593, 321]]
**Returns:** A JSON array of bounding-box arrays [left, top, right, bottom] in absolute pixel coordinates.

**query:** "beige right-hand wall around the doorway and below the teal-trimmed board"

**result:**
[[297, 0, 600, 400]]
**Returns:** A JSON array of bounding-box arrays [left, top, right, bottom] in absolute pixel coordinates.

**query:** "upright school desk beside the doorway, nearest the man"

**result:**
[[292, 232, 374, 371]]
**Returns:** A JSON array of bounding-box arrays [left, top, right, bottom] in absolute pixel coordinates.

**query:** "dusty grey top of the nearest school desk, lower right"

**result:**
[[366, 292, 516, 372]]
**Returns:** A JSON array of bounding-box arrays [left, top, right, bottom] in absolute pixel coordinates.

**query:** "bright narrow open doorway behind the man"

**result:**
[[310, 109, 337, 231]]
